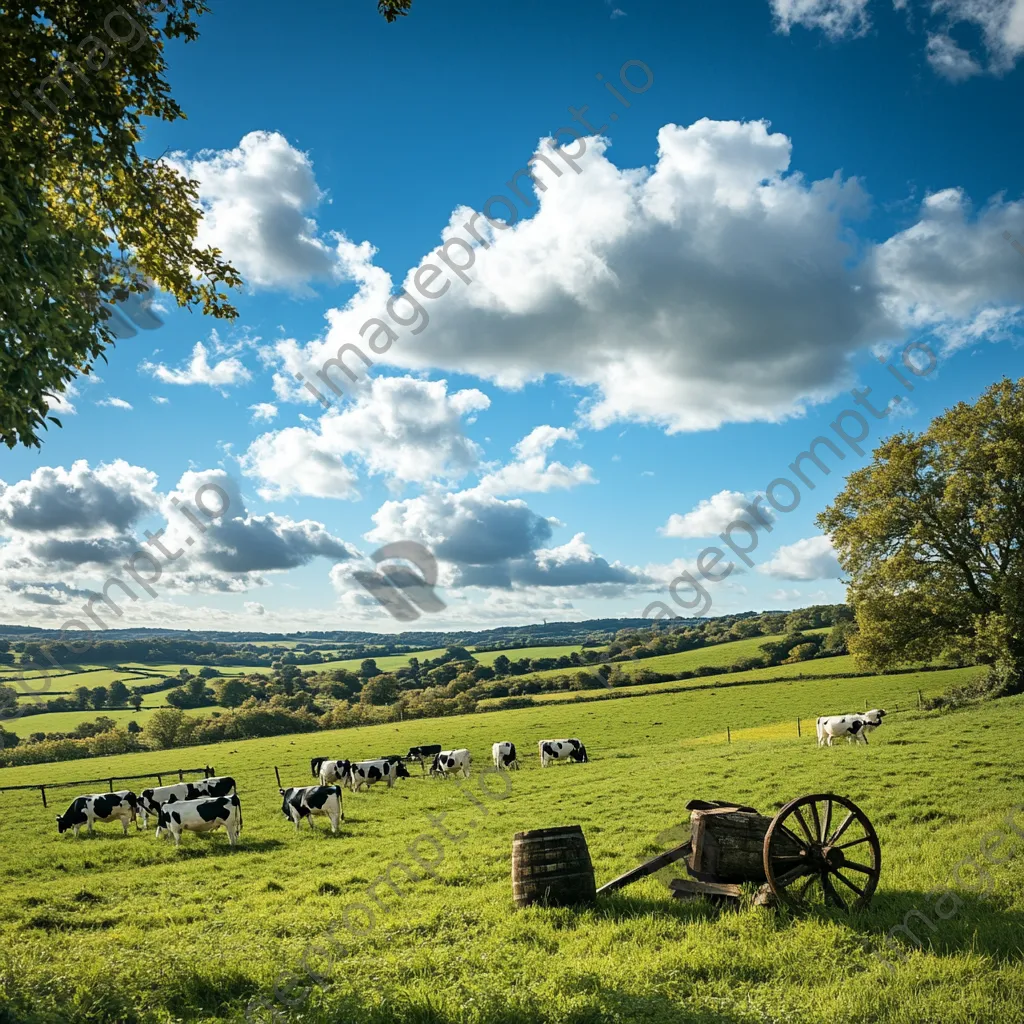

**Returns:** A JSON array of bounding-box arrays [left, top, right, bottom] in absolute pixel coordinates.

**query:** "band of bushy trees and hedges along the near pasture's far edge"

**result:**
[[0, 605, 855, 766]]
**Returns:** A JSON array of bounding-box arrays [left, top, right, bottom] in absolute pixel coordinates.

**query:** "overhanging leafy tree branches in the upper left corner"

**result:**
[[0, 0, 242, 447]]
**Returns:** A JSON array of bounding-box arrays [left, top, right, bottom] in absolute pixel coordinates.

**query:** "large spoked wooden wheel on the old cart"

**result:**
[[764, 793, 882, 910]]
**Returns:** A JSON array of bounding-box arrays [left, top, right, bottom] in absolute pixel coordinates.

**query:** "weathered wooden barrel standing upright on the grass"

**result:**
[[512, 825, 597, 906]]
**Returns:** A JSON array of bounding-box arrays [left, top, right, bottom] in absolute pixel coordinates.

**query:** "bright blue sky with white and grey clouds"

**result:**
[[0, 0, 1024, 631]]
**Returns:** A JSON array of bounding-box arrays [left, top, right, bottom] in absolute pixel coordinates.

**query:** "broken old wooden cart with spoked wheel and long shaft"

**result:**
[[597, 793, 882, 910]]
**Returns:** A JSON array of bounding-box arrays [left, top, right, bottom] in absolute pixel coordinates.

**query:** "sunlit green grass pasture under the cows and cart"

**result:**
[[0, 676, 1024, 1024]]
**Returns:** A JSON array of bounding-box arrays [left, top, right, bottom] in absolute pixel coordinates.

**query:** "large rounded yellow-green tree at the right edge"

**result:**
[[818, 378, 1024, 692]]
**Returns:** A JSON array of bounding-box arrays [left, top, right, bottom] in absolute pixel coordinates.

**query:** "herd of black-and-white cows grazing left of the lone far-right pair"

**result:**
[[51, 738, 589, 847]]
